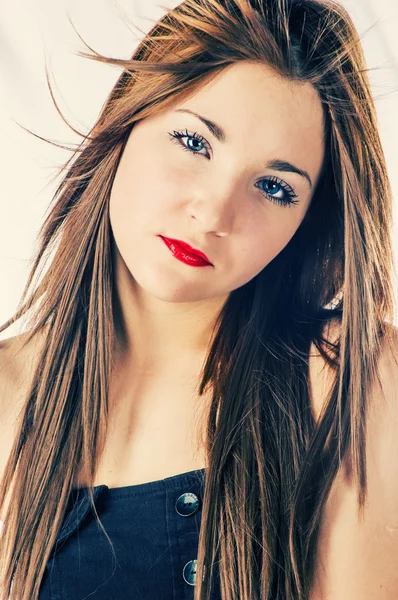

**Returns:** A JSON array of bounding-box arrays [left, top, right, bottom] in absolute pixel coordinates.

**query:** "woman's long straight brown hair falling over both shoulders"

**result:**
[[0, 0, 393, 600]]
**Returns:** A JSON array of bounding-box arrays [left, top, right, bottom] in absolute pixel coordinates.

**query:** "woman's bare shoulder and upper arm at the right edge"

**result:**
[[310, 325, 398, 600]]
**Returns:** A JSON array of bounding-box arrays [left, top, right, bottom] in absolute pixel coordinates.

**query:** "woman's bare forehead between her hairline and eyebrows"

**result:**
[[178, 61, 324, 179]]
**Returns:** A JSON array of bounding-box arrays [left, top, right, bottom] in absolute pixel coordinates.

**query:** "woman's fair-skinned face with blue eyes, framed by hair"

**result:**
[[110, 62, 324, 302]]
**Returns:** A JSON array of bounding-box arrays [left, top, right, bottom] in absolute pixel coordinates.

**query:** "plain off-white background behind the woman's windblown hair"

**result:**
[[0, 0, 398, 339]]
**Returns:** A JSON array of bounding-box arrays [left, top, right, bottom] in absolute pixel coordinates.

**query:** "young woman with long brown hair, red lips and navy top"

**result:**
[[0, 0, 398, 600]]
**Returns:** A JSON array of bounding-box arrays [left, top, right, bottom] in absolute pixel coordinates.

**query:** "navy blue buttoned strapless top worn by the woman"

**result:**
[[39, 469, 221, 600]]
